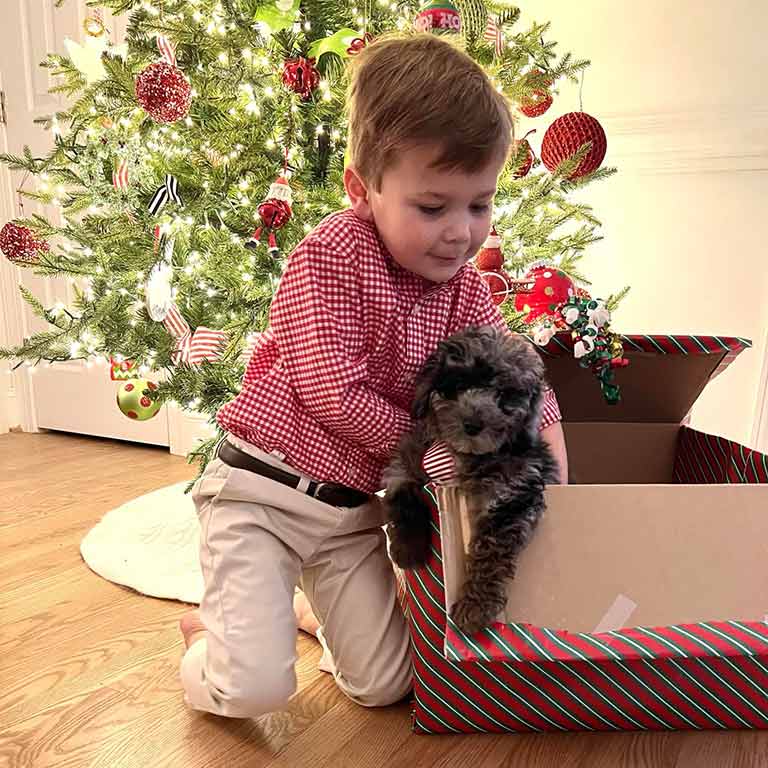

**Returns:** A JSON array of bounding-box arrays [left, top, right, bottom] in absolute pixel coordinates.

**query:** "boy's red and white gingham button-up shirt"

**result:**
[[217, 211, 560, 493]]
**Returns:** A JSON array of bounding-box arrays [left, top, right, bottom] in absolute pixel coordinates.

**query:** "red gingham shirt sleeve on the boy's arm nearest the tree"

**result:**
[[270, 240, 410, 458]]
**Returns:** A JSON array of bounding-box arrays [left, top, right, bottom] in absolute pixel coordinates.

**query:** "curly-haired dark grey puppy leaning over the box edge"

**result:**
[[385, 327, 558, 632]]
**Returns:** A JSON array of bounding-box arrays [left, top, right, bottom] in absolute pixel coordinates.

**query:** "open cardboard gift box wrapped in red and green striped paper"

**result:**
[[407, 336, 768, 733]]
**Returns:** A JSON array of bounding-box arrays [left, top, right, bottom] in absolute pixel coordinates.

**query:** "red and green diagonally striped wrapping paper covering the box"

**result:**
[[406, 334, 768, 733]]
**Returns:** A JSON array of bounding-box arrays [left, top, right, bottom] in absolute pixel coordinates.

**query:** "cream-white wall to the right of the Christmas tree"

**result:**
[[520, 0, 768, 450]]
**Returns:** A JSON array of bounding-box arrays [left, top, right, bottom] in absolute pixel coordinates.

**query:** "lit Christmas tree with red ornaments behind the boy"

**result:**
[[0, 0, 620, 472]]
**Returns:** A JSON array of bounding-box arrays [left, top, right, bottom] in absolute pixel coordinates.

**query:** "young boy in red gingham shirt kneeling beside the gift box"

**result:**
[[181, 34, 565, 717]]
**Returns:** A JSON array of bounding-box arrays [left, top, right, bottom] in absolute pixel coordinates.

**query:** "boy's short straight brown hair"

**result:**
[[348, 33, 514, 188]]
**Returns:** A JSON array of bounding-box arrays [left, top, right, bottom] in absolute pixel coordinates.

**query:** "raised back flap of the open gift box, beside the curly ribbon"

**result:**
[[541, 333, 752, 424]]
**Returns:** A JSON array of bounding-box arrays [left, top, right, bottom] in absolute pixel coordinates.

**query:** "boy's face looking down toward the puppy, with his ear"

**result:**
[[345, 147, 504, 283]]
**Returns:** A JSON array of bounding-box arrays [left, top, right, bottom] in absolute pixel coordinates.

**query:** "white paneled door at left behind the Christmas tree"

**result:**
[[0, 0, 171, 452]]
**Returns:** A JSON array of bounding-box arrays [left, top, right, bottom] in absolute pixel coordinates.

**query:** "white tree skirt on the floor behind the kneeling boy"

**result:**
[[80, 482, 203, 603]]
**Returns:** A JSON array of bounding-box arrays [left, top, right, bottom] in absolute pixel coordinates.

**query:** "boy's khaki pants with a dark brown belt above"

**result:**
[[181, 442, 412, 717]]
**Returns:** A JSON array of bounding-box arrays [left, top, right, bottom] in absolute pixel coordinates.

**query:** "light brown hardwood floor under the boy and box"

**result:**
[[0, 434, 768, 768]]
